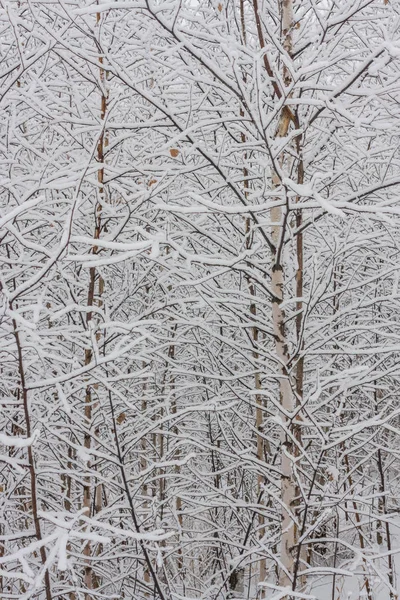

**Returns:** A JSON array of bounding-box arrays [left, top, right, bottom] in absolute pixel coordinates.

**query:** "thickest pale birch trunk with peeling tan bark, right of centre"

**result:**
[[253, 0, 304, 588]]
